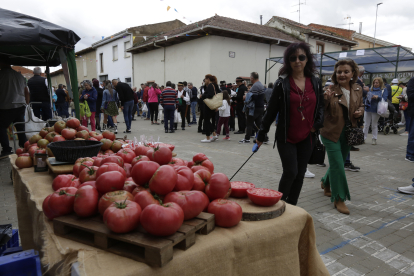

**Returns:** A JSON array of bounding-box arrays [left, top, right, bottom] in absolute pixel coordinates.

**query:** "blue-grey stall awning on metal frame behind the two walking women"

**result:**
[[266, 46, 414, 81]]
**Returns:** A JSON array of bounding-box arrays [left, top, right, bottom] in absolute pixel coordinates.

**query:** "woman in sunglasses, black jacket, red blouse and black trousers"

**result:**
[[256, 42, 324, 205]]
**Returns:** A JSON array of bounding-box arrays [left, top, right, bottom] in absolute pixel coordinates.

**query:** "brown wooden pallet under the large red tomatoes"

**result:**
[[53, 213, 215, 267]]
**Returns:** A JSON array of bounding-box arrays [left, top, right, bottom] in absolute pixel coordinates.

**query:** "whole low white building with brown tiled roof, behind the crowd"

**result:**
[[129, 16, 297, 87]]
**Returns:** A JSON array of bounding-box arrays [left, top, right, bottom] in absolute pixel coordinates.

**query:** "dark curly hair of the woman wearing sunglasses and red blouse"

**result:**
[[279, 42, 316, 77]]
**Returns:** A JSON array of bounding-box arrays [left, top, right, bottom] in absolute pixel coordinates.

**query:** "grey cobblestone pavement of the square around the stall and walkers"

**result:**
[[0, 116, 414, 276]]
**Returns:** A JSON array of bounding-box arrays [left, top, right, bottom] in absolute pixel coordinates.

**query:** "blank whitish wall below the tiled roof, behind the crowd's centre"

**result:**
[[133, 36, 286, 86]]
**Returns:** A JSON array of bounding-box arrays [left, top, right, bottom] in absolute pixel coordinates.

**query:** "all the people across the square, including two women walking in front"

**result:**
[[0, 43, 414, 214]]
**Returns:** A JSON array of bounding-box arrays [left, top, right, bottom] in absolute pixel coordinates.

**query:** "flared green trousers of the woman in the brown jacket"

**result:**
[[321, 128, 351, 202]]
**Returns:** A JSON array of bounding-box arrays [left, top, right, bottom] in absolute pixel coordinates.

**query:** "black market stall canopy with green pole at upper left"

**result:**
[[0, 8, 80, 117]]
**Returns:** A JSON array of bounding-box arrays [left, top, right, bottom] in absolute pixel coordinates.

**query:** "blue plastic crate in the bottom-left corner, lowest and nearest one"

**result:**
[[0, 249, 42, 276]]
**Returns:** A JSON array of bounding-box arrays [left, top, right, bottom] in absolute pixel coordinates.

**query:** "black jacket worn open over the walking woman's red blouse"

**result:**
[[257, 75, 324, 147]]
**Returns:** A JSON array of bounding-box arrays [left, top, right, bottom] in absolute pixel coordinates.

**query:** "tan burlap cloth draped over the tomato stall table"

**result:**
[[10, 155, 329, 276]]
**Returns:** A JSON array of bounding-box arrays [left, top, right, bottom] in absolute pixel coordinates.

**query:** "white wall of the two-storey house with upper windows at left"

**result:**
[[96, 35, 134, 85]]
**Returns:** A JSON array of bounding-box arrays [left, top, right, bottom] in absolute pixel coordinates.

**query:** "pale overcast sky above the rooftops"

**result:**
[[2, 0, 414, 71]]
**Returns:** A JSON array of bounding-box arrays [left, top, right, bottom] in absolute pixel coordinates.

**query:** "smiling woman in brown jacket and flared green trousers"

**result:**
[[321, 59, 364, 215]]
